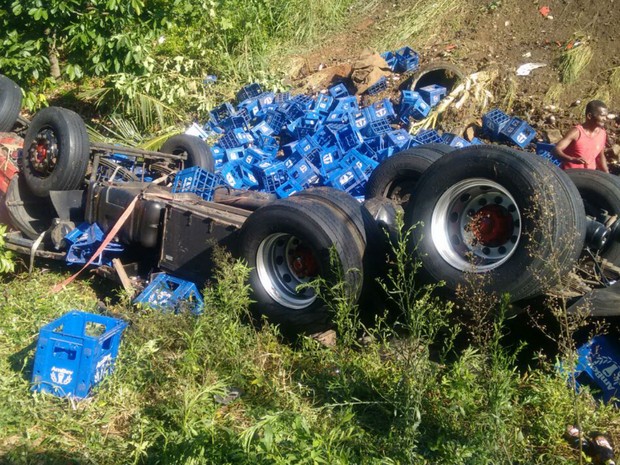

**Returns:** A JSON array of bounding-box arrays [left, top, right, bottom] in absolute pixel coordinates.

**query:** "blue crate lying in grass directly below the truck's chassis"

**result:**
[[133, 273, 204, 315]]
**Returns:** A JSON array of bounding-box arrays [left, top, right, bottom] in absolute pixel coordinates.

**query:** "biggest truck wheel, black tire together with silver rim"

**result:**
[[405, 146, 586, 301]]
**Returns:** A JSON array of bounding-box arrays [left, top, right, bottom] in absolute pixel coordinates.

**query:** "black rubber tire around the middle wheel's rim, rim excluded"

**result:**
[[239, 199, 363, 333]]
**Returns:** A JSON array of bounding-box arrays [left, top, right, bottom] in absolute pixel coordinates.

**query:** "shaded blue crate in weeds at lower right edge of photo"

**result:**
[[574, 336, 620, 402]]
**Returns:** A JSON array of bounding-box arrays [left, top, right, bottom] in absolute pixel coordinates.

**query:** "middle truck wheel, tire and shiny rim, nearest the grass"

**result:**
[[239, 198, 364, 333]]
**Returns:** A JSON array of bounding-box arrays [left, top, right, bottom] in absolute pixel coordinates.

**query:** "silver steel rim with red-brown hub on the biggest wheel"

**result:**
[[431, 178, 522, 272]]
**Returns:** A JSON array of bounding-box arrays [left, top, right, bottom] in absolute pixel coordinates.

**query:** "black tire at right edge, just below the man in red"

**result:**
[[565, 169, 620, 266]]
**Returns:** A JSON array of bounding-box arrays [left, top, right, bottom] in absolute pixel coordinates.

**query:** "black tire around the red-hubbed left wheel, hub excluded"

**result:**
[[21, 107, 90, 197]]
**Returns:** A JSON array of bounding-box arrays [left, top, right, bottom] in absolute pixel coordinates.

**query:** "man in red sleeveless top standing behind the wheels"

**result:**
[[553, 100, 609, 173]]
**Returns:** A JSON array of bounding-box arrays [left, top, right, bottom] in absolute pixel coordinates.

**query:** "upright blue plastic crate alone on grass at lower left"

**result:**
[[32, 310, 127, 399]]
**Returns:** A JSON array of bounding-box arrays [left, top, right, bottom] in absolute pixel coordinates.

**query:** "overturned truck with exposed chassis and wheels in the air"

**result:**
[[0, 75, 620, 332]]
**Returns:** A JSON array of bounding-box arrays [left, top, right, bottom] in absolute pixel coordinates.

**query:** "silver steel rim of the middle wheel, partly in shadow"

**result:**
[[256, 233, 318, 310]]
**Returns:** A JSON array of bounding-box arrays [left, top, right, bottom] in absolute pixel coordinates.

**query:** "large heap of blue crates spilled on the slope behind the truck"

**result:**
[[194, 67, 548, 198]]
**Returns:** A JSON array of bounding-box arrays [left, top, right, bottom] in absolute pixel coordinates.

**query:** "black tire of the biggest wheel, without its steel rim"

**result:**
[[405, 146, 585, 301]]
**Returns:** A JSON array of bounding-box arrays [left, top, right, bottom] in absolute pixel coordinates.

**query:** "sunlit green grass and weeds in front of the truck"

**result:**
[[0, 234, 615, 464]]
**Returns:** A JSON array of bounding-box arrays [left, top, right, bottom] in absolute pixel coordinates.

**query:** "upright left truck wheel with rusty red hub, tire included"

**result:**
[[21, 107, 90, 197]]
